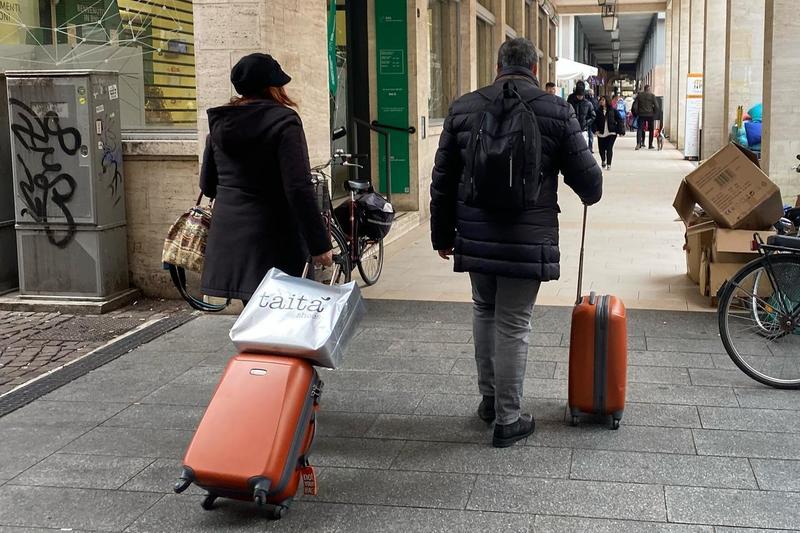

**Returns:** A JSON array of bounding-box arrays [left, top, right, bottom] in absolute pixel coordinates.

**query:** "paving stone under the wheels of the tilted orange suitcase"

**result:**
[[125, 493, 267, 533]]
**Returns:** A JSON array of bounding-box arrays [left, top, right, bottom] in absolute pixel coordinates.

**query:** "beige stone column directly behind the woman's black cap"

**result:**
[[194, 0, 330, 162]]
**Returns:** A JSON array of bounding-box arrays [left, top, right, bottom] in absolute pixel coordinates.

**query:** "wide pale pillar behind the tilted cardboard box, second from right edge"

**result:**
[[724, 0, 764, 136]]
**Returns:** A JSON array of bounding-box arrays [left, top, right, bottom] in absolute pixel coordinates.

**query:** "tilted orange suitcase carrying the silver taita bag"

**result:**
[[175, 354, 322, 519]]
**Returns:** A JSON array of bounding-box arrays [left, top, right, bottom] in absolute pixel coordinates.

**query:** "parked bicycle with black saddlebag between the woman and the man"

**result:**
[[311, 128, 391, 285]]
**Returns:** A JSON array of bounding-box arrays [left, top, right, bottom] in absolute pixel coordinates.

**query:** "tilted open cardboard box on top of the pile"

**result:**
[[672, 144, 783, 230]]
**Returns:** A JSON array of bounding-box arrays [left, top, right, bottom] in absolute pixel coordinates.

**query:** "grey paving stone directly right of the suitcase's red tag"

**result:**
[[308, 467, 475, 510]]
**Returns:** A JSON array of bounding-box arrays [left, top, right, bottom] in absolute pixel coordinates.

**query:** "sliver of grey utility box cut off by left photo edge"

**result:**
[[0, 74, 19, 294]]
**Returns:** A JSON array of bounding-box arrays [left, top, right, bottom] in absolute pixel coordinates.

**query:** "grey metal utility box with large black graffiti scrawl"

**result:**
[[6, 71, 129, 298]]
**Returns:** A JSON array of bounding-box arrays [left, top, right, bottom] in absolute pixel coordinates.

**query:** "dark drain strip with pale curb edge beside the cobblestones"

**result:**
[[0, 313, 199, 417]]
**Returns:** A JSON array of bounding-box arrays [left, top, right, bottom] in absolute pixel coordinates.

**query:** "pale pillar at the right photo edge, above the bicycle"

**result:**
[[761, 0, 800, 200]]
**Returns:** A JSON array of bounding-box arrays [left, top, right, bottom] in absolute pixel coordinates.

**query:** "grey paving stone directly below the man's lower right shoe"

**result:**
[[392, 442, 572, 478]]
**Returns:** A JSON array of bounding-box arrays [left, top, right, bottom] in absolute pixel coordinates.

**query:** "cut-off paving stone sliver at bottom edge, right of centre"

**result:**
[[531, 515, 714, 533]]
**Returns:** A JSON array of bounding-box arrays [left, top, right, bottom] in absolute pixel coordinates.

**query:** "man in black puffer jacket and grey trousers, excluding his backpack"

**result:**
[[431, 39, 602, 447]]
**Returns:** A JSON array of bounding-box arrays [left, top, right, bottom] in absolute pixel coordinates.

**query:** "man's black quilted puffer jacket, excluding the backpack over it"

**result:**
[[431, 69, 603, 281]]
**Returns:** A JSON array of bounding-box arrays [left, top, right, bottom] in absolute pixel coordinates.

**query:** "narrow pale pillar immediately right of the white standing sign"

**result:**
[[700, 0, 728, 159]]
